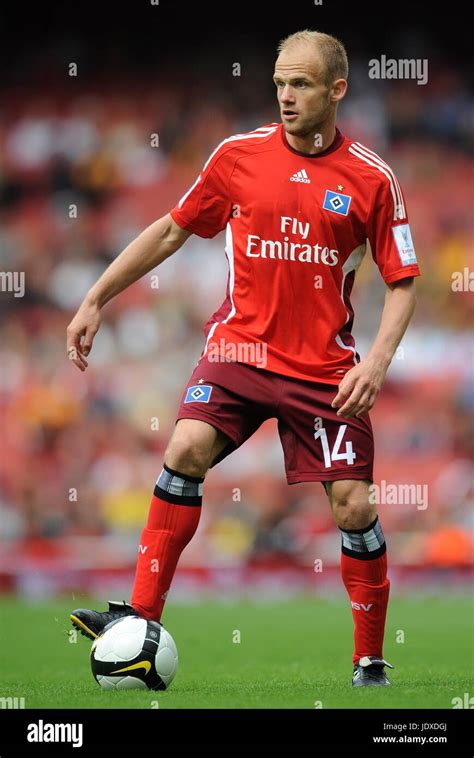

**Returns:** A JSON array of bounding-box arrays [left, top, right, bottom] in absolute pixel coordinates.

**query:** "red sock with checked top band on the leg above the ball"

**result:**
[[131, 466, 204, 621]]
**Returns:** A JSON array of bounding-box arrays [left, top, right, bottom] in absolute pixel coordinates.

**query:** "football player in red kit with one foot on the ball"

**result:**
[[67, 30, 419, 687]]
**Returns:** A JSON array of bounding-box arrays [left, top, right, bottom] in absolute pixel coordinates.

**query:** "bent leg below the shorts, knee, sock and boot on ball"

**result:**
[[70, 418, 230, 639]]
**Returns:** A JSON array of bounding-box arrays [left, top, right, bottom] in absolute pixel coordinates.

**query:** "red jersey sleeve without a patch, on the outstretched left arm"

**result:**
[[170, 145, 235, 237]]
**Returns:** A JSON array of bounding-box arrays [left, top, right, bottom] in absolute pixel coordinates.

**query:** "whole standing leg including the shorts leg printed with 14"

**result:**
[[278, 377, 390, 686]]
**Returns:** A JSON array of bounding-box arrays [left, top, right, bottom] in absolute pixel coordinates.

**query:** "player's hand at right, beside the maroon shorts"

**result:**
[[331, 358, 388, 418]]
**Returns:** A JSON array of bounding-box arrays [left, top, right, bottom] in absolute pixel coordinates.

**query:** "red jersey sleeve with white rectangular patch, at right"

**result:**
[[367, 172, 421, 284]]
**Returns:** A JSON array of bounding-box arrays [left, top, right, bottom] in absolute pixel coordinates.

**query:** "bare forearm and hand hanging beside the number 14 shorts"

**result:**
[[332, 277, 416, 418]]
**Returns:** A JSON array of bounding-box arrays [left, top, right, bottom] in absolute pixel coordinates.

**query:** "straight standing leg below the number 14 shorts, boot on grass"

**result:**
[[325, 479, 393, 687]]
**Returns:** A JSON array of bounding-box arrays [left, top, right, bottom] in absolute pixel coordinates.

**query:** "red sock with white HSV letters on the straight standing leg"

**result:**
[[341, 524, 390, 664]]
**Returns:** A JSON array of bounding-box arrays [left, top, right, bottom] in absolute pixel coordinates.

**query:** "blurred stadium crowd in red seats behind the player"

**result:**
[[0, 62, 474, 592]]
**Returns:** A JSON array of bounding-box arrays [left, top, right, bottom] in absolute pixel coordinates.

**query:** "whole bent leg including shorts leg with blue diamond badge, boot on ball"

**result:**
[[71, 358, 275, 639]]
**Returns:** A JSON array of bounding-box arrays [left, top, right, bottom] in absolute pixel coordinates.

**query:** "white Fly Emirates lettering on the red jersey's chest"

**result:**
[[246, 216, 339, 266]]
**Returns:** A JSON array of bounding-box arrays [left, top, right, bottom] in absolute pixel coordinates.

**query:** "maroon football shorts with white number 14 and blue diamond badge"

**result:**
[[177, 356, 374, 484]]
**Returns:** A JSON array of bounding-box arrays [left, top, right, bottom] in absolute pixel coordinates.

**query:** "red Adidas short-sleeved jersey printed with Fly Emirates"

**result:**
[[171, 123, 420, 384]]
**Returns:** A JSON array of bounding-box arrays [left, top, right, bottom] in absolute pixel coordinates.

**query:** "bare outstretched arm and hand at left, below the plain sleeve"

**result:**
[[67, 213, 191, 371]]
